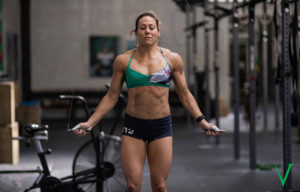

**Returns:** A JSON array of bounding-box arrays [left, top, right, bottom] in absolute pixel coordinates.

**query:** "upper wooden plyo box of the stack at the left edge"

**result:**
[[0, 82, 16, 126]]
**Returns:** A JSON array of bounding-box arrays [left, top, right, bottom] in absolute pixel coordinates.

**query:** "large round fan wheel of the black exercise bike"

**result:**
[[72, 135, 126, 192]]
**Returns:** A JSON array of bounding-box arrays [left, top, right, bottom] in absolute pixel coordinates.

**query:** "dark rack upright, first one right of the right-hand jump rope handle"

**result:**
[[232, 0, 240, 159]]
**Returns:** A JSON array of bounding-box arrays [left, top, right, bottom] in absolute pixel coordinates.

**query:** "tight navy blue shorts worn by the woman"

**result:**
[[122, 114, 172, 143]]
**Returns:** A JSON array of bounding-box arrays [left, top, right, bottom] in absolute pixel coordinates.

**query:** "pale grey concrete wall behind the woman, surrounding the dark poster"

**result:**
[[31, 0, 190, 91]]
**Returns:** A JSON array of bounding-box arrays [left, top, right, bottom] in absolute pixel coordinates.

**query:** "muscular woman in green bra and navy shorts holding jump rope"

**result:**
[[75, 12, 218, 192]]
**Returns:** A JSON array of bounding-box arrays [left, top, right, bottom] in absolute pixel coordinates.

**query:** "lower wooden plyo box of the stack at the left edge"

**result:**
[[0, 122, 20, 164]]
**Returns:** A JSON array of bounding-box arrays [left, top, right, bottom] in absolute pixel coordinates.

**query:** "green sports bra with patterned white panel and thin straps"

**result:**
[[125, 48, 172, 89]]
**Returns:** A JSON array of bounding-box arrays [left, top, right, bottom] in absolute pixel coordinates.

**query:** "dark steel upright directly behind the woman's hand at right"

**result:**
[[214, 0, 220, 145]]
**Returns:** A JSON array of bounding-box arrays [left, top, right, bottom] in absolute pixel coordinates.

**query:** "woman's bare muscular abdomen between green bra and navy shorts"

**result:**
[[126, 86, 170, 119]]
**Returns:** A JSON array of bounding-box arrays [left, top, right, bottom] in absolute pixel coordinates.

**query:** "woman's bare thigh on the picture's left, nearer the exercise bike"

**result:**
[[121, 135, 146, 185]]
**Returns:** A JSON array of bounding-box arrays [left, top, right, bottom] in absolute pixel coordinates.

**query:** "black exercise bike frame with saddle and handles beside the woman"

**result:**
[[0, 92, 126, 192]]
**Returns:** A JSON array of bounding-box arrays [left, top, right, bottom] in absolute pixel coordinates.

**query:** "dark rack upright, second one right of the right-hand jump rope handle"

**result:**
[[248, 0, 256, 169]]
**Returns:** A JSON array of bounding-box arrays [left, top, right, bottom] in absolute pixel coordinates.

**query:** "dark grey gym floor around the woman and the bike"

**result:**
[[0, 115, 300, 192]]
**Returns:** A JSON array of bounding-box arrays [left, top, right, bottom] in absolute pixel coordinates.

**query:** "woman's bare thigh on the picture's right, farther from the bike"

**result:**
[[148, 137, 173, 185]]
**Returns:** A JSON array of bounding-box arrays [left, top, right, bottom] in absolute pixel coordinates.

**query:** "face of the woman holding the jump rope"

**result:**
[[135, 16, 160, 45]]
